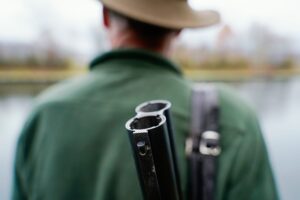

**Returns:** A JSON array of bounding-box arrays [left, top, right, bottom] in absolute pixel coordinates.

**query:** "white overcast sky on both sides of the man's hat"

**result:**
[[0, 0, 300, 57]]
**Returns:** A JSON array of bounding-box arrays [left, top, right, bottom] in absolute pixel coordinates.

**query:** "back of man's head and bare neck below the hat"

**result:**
[[103, 8, 180, 54]]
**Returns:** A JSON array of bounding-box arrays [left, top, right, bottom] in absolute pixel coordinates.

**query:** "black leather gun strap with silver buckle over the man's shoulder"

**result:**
[[186, 85, 221, 200]]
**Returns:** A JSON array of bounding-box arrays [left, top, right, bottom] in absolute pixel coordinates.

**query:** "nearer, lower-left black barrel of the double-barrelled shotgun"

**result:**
[[126, 113, 180, 200]]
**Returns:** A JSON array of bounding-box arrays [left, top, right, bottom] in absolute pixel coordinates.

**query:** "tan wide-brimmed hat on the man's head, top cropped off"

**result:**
[[100, 0, 220, 29]]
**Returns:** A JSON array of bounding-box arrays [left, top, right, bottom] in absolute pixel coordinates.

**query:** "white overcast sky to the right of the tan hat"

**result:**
[[190, 0, 300, 35]]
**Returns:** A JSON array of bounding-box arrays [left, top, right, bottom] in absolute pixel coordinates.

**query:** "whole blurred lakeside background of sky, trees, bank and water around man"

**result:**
[[0, 0, 300, 200]]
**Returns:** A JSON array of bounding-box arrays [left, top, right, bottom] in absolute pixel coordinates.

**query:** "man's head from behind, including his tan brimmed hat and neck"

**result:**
[[100, 0, 220, 53]]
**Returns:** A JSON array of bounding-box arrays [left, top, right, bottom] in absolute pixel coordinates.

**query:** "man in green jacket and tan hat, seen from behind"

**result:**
[[13, 0, 278, 200]]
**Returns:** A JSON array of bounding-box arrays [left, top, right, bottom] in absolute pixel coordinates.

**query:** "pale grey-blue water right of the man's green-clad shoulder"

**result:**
[[237, 78, 300, 200]]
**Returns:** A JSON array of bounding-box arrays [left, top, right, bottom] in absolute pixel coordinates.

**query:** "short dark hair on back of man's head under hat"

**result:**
[[107, 9, 178, 45]]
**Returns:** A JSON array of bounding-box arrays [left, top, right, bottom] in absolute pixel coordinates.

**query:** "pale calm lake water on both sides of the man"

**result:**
[[0, 78, 300, 200]]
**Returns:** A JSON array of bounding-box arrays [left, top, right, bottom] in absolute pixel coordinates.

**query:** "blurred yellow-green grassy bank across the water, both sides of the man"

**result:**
[[0, 68, 300, 84]]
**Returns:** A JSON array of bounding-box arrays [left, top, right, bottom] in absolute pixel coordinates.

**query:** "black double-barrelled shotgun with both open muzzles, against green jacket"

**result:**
[[126, 100, 182, 200]]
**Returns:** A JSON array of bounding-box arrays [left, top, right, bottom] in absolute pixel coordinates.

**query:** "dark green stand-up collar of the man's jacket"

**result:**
[[90, 49, 182, 75]]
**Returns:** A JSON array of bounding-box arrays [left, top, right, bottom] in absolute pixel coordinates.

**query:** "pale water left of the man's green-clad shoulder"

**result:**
[[0, 96, 32, 200]]
